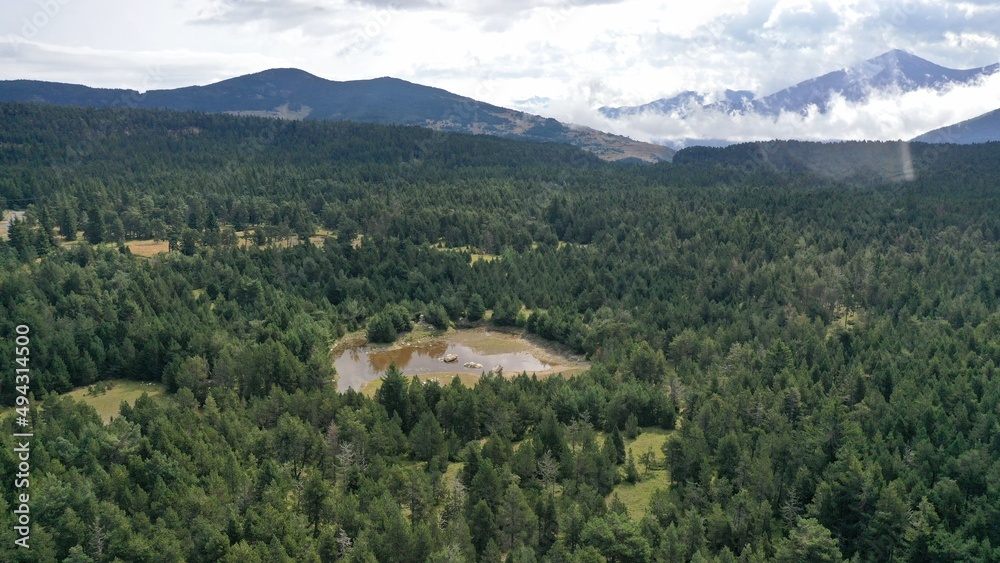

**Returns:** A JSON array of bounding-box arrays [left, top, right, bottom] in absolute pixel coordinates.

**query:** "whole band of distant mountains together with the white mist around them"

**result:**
[[0, 50, 1000, 152]]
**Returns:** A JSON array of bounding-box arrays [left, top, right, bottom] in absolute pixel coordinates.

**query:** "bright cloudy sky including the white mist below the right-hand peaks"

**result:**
[[0, 0, 1000, 140]]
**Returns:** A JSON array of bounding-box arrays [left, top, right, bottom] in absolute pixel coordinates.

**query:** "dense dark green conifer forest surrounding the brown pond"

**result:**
[[0, 104, 1000, 563]]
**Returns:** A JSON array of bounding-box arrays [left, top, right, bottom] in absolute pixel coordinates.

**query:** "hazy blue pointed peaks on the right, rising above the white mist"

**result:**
[[599, 49, 1000, 119]]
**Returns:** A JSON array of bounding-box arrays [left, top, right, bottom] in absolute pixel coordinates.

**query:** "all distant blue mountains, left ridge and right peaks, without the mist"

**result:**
[[0, 50, 1000, 154]]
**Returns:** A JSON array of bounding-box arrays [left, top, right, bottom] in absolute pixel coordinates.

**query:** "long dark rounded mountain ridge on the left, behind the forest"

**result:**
[[0, 68, 674, 162]]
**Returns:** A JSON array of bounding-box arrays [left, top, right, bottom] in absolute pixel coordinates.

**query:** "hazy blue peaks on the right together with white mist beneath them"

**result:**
[[598, 49, 1000, 148]]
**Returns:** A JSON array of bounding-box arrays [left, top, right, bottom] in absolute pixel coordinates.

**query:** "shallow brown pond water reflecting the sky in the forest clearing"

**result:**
[[333, 339, 552, 391]]
